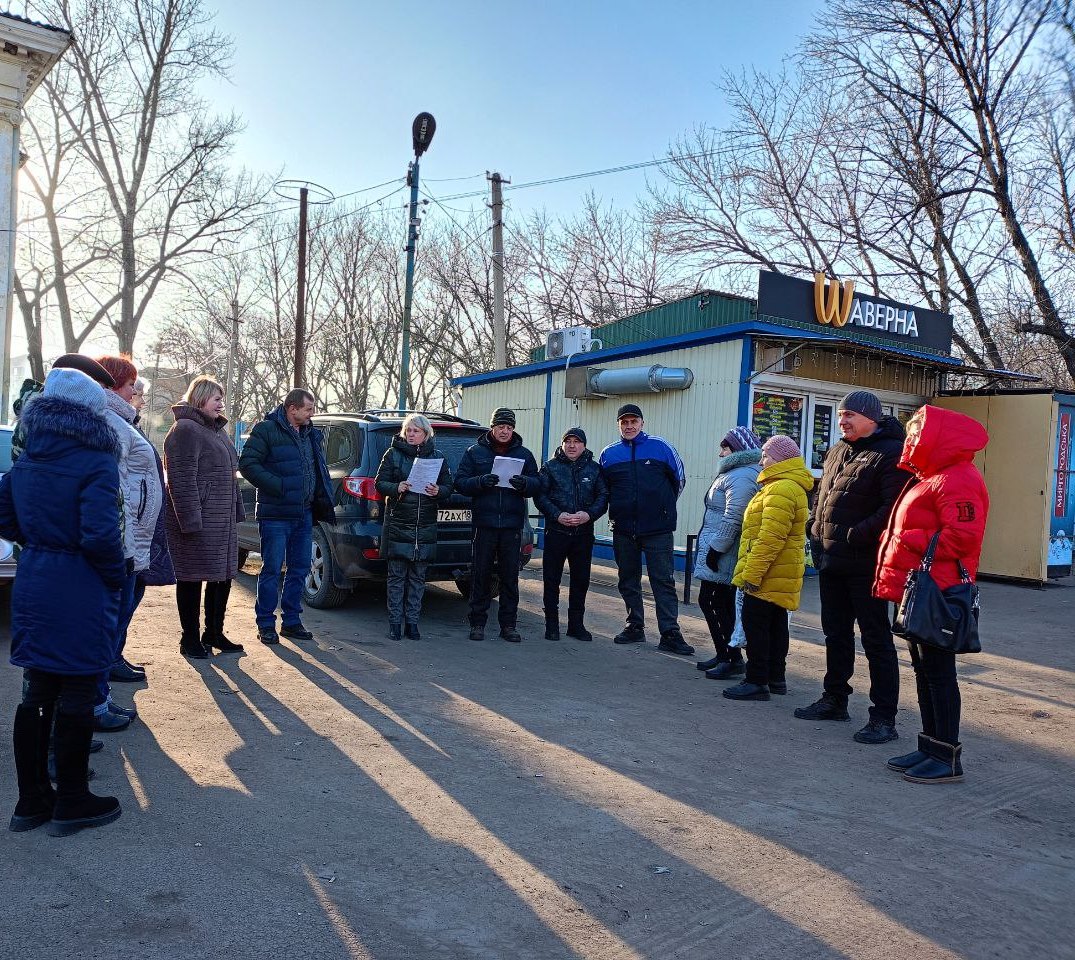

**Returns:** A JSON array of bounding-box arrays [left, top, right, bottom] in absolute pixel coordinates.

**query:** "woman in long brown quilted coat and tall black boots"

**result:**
[[164, 376, 246, 660]]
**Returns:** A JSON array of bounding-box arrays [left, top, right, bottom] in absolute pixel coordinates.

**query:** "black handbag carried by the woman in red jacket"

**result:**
[[892, 530, 981, 654]]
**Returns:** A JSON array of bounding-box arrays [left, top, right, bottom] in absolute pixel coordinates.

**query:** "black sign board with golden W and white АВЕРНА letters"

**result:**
[[758, 270, 951, 354]]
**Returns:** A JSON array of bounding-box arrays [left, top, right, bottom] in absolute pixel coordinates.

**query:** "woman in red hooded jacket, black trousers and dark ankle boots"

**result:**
[[873, 405, 989, 783]]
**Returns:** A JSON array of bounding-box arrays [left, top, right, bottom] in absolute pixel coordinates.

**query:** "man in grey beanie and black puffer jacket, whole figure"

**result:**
[[796, 390, 911, 744]]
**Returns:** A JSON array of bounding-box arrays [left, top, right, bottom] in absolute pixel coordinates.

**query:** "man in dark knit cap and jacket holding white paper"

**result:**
[[456, 406, 541, 643]]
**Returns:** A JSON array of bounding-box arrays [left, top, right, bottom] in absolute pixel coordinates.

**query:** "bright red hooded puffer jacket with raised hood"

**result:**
[[873, 404, 989, 603]]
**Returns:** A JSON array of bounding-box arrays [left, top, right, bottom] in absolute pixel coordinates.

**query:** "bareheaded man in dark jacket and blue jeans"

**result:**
[[239, 389, 335, 644]]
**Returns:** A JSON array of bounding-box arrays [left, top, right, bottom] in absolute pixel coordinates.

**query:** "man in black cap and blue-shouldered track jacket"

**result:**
[[601, 403, 694, 657]]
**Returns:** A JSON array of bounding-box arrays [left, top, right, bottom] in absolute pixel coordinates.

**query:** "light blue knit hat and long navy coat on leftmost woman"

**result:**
[[0, 370, 127, 676]]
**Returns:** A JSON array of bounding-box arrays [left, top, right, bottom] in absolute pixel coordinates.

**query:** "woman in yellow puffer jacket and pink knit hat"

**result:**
[[723, 435, 814, 700]]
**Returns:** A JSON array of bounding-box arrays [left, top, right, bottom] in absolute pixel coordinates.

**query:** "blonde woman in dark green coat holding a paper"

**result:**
[[376, 413, 452, 640]]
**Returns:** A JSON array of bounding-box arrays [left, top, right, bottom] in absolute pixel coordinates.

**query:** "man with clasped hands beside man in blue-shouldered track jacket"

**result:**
[[534, 427, 608, 640]]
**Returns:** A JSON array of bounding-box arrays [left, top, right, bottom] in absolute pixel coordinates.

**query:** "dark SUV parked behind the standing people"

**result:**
[[239, 410, 533, 608]]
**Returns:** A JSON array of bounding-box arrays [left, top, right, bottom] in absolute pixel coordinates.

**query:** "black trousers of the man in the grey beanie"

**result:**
[[818, 570, 900, 723]]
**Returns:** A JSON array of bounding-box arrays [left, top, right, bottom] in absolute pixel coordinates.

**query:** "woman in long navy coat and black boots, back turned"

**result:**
[[0, 369, 130, 836]]
